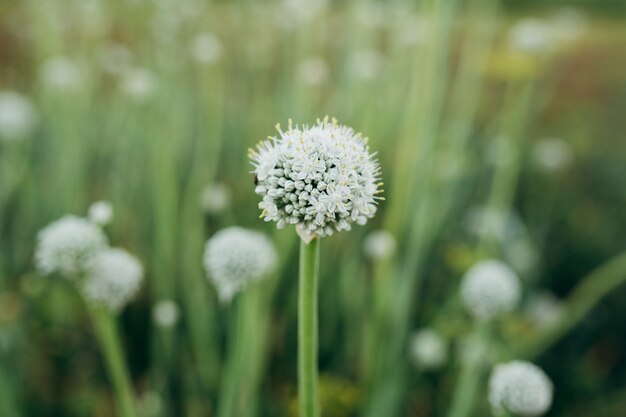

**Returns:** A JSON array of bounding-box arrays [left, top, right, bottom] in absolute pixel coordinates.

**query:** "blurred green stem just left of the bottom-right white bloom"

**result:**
[[448, 323, 490, 417]]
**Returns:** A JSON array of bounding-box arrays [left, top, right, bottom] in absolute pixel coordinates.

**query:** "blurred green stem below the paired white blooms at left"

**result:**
[[87, 307, 139, 417]]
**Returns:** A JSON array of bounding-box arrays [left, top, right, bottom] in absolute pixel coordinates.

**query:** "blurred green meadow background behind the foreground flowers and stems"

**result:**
[[0, 0, 626, 417]]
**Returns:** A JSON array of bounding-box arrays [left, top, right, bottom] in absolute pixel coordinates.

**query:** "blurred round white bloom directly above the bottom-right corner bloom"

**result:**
[[461, 260, 521, 320]]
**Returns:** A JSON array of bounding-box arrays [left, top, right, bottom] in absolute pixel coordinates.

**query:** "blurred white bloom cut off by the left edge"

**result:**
[[0, 91, 37, 142]]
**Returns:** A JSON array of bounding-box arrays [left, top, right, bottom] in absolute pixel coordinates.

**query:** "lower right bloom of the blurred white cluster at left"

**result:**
[[82, 248, 143, 312]]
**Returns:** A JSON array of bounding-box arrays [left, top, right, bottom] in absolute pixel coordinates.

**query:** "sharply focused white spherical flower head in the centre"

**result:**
[[250, 119, 382, 240]]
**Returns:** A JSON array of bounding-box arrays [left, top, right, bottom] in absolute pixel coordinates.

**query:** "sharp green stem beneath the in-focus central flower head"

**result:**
[[298, 238, 320, 417]]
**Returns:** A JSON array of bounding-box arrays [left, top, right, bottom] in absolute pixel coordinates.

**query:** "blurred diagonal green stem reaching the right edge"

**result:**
[[519, 252, 626, 360]]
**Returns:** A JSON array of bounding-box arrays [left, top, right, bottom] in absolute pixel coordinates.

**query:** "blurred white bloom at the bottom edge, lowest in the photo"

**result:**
[[489, 361, 554, 417]]
